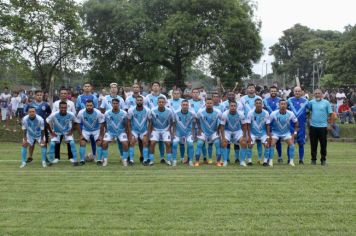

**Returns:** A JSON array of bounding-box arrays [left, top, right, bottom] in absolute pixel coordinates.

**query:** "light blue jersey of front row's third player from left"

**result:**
[[76, 108, 105, 132]]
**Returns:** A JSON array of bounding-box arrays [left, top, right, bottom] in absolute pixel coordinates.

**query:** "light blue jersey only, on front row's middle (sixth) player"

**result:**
[[149, 107, 173, 131]]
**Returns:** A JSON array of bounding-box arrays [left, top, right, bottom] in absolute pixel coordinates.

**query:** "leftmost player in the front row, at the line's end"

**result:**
[[20, 106, 47, 168]]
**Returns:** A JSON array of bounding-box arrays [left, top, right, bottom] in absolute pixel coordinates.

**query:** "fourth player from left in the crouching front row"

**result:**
[[100, 98, 129, 166]]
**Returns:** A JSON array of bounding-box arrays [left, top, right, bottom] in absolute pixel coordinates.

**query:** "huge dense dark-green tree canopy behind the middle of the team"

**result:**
[[83, 0, 262, 86]]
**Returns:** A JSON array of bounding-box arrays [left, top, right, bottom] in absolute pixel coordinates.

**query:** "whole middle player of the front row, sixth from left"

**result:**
[[145, 97, 173, 165]]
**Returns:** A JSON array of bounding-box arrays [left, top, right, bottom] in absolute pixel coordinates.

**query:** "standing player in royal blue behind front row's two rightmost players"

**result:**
[[263, 86, 283, 163]]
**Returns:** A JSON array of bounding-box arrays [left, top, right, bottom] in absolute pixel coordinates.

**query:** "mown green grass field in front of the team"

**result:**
[[0, 142, 356, 236]]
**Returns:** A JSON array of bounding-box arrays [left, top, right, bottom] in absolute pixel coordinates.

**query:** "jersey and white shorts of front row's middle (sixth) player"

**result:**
[[149, 107, 174, 142]]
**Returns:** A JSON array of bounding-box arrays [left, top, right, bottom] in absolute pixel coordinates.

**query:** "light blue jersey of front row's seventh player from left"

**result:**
[[174, 110, 196, 137]]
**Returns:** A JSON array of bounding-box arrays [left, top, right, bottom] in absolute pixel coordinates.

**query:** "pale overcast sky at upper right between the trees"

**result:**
[[253, 0, 356, 74]]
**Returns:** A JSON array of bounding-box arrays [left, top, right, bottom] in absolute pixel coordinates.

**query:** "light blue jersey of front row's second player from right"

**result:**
[[246, 109, 270, 137]]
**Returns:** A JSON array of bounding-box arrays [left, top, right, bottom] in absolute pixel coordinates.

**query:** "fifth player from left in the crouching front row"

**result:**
[[127, 96, 150, 165]]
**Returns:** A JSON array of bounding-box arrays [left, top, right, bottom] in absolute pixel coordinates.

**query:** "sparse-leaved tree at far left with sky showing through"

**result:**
[[6, 0, 85, 90]]
